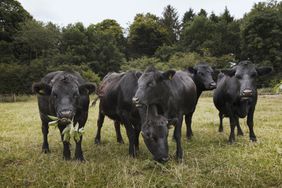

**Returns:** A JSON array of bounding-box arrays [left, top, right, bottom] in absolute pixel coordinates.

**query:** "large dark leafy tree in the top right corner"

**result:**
[[241, 1, 282, 72]]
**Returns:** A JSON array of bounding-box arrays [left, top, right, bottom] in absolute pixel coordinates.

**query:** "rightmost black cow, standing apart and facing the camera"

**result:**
[[213, 61, 272, 143]]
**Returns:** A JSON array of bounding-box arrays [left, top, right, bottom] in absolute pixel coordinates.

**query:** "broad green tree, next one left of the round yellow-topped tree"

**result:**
[[86, 20, 125, 77]]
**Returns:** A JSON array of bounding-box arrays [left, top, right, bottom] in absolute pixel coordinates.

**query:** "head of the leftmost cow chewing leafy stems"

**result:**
[[32, 74, 96, 124]]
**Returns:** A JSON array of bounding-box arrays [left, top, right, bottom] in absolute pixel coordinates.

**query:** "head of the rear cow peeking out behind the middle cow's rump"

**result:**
[[187, 63, 216, 90]]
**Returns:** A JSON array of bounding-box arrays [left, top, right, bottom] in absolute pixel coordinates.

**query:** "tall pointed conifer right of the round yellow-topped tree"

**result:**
[[160, 5, 180, 44]]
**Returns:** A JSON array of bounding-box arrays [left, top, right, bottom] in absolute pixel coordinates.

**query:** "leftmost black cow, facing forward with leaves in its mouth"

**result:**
[[32, 71, 96, 160]]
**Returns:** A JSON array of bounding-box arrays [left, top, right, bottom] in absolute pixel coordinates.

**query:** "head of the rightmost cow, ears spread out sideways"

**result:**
[[222, 61, 272, 99]]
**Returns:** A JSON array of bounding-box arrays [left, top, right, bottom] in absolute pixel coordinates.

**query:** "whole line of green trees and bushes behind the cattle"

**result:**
[[0, 0, 282, 94]]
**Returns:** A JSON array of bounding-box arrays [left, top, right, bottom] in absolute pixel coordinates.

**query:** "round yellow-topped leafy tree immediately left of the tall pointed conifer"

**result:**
[[127, 13, 168, 57]]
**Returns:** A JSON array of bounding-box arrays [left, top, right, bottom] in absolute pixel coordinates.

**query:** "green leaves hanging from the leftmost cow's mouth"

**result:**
[[48, 115, 85, 142]]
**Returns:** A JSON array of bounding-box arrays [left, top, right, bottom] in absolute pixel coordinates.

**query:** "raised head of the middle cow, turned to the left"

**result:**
[[132, 67, 175, 107]]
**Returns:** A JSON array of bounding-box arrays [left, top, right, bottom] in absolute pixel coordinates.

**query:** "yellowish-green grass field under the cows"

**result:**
[[0, 96, 282, 188]]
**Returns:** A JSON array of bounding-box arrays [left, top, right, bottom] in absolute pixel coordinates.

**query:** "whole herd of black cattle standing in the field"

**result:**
[[33, 61, 272, 162]]
